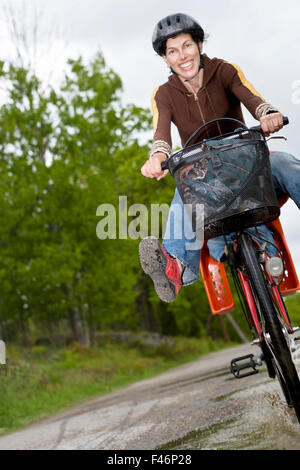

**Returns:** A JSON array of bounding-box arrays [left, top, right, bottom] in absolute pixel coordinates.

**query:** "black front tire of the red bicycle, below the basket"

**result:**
[[239, 233, 300, 423]]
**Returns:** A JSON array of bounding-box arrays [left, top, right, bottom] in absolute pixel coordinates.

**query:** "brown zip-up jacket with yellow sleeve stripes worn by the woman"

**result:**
[[151, 54, 275, 150]]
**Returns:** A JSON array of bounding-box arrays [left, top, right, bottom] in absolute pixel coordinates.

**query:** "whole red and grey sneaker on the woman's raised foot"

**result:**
[[139, 237, 182, 302]]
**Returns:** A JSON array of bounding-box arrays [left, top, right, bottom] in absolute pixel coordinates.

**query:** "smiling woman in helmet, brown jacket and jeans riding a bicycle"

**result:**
[[139, 13, 300, 302]]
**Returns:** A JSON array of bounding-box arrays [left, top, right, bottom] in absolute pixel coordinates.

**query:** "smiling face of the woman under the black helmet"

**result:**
[[163, 33, 202, 80]]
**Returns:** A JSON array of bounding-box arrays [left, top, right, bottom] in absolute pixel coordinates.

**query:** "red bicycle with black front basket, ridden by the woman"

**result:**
[[162, 118, 300, 423]]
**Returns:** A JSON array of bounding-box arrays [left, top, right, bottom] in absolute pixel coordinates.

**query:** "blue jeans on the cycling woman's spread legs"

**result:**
[[162, 152, 300, 285]]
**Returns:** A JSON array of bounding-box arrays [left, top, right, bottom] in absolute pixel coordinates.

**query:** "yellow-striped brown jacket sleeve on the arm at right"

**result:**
[[224, 63, 277, 120]]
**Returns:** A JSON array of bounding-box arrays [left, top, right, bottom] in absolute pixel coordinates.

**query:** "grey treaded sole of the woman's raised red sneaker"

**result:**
[[139, 238, 177, 303]]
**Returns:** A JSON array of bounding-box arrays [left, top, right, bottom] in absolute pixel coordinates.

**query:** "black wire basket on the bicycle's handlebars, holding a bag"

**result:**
[[167, 118, 280, 240]]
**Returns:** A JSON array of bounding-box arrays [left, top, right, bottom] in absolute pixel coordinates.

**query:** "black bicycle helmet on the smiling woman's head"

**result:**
[[152, 13, 204, 55]]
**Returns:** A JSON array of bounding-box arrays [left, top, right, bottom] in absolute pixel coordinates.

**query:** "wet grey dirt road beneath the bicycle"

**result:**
[[0, 345, 300, 450]]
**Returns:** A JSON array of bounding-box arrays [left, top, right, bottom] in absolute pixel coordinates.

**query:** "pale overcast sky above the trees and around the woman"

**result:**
[[0, 0, 300, 275]]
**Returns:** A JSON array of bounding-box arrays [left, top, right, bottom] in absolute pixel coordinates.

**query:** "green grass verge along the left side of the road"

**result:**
[[0, 336, 234, 435]]
